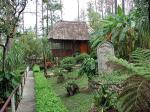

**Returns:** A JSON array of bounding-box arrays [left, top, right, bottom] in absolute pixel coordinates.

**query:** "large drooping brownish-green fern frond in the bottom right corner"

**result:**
[[120, 75, 150, 112]]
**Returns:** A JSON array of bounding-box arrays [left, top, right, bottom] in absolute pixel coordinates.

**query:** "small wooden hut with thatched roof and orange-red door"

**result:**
[[48, 21, 89, 57]]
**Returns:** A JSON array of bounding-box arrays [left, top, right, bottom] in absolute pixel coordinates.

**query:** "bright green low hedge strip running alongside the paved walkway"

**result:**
[[33, 66, 68, 112]]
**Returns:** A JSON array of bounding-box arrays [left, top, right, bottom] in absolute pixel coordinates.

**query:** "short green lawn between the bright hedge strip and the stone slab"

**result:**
[[49, 71, 94, 112]]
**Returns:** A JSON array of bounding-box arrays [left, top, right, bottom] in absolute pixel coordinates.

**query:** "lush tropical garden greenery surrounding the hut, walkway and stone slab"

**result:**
[[0, 0, 150, 112]]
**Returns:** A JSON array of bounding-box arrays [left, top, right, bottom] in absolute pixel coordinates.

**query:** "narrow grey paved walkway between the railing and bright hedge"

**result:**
[[17, 71, 35, 112]]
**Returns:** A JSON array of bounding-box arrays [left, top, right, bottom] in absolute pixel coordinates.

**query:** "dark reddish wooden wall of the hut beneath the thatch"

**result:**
[[51, 40, 89, 57]]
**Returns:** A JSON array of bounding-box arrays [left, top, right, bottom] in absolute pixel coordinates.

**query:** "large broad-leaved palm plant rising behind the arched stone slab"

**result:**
[[90, 6, 137, 59]]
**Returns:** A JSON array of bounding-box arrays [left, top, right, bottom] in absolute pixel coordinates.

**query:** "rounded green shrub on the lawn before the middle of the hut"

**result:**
[[60, 57, 76, 71]]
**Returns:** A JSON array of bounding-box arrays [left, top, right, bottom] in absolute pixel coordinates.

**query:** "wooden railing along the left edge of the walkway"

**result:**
[[0, 67, 29, 112]]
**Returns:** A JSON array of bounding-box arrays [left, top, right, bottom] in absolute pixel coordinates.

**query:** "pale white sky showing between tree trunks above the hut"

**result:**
[[24, 0, 90, 29]]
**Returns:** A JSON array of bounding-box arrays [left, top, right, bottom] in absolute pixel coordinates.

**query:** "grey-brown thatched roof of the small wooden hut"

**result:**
[[48, 21, 89, 40]]
